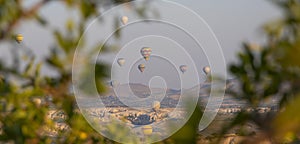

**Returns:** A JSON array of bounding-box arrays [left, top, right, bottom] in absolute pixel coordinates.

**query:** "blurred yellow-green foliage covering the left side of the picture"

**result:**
[[0, 0, 136, 143]]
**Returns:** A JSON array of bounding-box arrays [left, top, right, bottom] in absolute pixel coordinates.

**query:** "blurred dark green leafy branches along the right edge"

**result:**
[[223, 0, 300, 143]]
